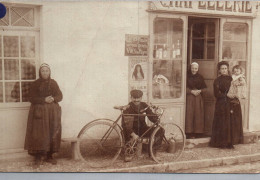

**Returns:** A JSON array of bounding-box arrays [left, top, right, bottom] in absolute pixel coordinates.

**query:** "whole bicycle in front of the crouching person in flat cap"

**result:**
[[78, 105, 185, 167]]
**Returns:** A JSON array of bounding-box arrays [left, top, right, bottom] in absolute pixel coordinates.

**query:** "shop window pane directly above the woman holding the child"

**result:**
[[222, 41, 247, 61]]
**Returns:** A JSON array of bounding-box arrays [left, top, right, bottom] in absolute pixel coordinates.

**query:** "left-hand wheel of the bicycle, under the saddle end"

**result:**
[[78, 119, 123, 167]]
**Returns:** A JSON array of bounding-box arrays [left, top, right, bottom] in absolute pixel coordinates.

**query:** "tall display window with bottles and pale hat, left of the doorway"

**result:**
[[152, 18, 183, 99]]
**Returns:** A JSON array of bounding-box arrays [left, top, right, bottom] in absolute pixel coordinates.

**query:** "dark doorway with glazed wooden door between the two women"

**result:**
[[187, 17, 220, 136]]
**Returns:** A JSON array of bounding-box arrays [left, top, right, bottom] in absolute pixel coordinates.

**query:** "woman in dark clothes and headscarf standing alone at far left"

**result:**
[[24, 63, 62, 166]]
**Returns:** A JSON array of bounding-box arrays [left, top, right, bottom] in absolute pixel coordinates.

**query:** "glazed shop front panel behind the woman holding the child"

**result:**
[[219, 19, 251, 130]]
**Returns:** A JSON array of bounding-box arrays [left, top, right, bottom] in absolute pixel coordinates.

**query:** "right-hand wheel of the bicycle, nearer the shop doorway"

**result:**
[[150, 123, 185, 163]]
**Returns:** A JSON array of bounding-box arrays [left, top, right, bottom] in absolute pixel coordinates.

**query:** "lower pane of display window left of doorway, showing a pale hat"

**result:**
[[152, 60, 182, 99]]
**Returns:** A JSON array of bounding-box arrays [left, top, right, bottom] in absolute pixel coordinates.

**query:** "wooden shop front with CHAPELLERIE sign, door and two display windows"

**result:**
[[144, 1, 256, 135]]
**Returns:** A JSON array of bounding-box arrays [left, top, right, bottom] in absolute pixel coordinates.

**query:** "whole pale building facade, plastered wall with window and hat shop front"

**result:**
[[0, 1, 260, 154]]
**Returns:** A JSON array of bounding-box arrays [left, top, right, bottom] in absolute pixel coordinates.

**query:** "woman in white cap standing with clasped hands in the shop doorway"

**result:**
[[185, 62, 207, 138]]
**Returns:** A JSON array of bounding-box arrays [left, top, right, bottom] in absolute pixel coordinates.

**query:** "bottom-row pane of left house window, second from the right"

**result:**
[[5, 82, 20, 102]]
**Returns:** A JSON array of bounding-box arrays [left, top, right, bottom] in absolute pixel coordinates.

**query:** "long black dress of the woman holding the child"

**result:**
[[210, 75, 243, 148]]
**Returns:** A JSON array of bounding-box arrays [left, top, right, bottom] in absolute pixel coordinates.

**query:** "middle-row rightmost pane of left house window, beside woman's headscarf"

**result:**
[[21, 59, 36, 80]]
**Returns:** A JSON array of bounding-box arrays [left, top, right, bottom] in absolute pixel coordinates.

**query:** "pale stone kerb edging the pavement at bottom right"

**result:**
[[100, 153, 260, 173]]
